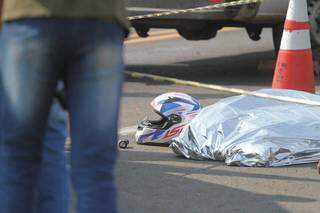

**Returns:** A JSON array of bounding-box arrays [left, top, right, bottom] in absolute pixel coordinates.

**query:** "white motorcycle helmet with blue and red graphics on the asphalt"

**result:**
[[135, 92, 201, 144]]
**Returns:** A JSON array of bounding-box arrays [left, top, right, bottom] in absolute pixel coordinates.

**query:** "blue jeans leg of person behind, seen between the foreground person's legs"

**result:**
[[35, 99, 69, 213]]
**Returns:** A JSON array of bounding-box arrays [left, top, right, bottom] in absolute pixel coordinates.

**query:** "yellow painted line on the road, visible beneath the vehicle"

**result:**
[[125, 27, 240, 44]]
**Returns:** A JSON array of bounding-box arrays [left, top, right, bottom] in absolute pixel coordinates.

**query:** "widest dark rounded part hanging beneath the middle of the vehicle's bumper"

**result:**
[[177, 25, 218, 41]]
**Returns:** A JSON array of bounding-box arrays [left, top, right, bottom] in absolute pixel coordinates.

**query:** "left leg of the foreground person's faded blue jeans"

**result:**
[[0, 22, 57, 213]]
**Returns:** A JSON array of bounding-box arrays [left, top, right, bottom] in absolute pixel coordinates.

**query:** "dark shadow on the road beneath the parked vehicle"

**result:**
[[126, 51, 275, 86]]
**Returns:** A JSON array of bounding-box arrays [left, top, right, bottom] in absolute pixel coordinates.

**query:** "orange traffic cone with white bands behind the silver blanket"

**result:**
[[272, 0, 315, 93]]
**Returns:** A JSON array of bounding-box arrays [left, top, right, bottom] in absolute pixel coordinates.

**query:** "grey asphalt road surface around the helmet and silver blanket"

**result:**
[[116, 30, 320, 213]]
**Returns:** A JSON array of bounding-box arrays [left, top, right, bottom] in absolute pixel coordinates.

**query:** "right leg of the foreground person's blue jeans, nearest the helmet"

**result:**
[[67, 22, 123, 213]]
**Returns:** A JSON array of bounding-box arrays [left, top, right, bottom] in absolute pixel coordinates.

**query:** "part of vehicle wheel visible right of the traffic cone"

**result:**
[[308, 0, 320, 48]]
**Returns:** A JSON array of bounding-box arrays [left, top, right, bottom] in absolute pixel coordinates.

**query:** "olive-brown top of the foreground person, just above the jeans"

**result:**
[[2, 0, 129, 29]]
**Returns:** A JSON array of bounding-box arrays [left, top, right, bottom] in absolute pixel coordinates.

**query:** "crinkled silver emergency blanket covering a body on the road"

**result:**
[[170, 89, 320, 167]]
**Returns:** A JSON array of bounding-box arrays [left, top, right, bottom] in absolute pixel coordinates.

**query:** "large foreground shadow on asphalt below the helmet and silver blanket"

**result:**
[[116, 151, 318, 213]]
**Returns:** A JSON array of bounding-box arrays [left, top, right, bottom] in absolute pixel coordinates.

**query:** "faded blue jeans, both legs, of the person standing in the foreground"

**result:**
[[0, 18, 123, 213]]
